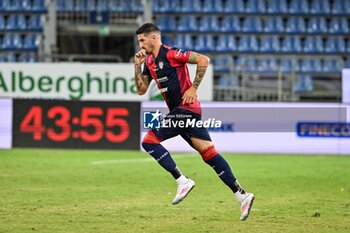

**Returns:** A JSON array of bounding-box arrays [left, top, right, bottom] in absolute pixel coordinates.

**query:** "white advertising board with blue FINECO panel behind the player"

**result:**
[[141, 102, 350, 155]]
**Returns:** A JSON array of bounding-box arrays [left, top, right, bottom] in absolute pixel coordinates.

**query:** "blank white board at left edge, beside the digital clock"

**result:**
[[0, 99, 12, 149]]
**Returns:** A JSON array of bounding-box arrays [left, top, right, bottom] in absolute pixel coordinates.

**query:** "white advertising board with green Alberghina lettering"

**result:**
[[0, 63, 213, 101]]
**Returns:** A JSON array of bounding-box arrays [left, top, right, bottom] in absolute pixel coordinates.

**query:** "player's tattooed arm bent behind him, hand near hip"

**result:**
[[182, 51, 210, 104]]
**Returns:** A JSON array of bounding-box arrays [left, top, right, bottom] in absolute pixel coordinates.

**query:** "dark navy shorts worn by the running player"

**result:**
[[152, 108, 211, 147]]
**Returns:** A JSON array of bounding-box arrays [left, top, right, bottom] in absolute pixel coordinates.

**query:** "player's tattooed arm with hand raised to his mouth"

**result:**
[[134, 50, 152, 95]]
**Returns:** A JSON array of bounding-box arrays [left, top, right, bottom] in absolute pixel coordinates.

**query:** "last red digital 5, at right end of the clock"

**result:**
[[106, 108, 130, 142]]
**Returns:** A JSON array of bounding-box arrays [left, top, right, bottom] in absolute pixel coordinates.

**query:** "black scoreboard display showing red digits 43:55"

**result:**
[[13, 99, 140, 149]]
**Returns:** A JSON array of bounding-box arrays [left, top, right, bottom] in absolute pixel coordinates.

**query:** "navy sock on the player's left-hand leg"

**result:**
[[142, 142, 181, 179]]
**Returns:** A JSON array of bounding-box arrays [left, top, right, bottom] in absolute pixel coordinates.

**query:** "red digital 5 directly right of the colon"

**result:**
[[80, 107, 103, 142]]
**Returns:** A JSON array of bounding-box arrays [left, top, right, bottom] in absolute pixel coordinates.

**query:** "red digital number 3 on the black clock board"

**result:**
[[47, 106, 71, 142]]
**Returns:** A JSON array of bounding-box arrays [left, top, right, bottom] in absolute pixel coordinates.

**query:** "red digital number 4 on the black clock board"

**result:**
[[19, 106, 45, 141]]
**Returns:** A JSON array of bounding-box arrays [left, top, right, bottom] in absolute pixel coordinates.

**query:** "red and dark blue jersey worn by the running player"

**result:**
[[142, 45, 202, 114]]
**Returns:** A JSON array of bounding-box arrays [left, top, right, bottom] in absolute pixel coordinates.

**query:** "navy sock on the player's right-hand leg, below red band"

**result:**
[[205, 154, 238, 192]]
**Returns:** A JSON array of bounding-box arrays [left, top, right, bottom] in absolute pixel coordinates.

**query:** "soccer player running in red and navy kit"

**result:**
[[134, 23, 254, 221]]
